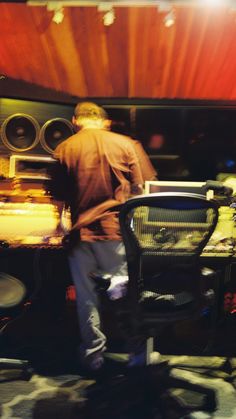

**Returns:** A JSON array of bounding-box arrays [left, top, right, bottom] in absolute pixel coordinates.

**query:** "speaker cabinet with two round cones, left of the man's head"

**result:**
[[0, 98, 74, 156]]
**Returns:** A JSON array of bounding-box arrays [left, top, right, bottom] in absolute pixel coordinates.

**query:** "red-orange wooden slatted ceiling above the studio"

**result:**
[[0, 3, 236, 99]]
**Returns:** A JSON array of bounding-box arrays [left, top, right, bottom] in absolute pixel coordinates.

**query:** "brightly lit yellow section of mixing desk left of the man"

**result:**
[[0, 181, 70, 248]]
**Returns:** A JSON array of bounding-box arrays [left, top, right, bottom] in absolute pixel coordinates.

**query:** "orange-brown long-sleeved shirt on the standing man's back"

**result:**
[[52, 129, 143, 240]]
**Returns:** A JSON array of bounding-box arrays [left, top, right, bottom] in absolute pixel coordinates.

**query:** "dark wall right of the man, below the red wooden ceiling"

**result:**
[[103, 104, 236, 181]]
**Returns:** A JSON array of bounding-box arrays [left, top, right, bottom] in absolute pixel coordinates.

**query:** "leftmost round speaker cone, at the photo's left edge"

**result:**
[[1, 113, 40, 152]]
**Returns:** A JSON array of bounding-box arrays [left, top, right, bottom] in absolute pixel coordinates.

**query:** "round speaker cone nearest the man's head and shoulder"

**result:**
[[40, 118, 74, 153]]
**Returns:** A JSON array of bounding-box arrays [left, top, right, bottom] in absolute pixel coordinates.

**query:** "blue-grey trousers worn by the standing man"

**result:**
[[69, 241, 127, 358]]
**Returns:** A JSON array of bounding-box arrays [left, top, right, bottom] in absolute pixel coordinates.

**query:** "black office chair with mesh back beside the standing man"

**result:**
[[117, 193, 218, 410]]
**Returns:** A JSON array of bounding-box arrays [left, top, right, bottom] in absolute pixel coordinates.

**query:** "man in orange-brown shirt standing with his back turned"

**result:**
[[50, 102, 143, 370]]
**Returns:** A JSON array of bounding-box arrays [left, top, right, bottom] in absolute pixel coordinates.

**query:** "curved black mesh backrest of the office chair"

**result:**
[[120, 193, 218, 318]]
